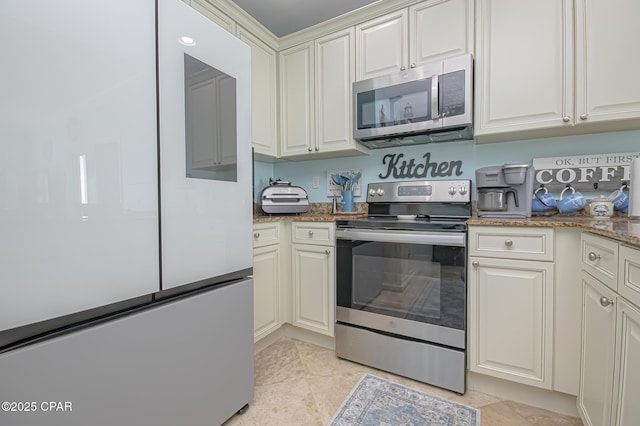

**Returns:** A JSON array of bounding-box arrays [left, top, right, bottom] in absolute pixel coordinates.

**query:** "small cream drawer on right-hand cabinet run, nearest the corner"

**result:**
[[580, 233, 618, 291]]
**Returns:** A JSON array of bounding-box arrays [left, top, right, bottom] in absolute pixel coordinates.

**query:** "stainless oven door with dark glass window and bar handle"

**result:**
[[336, 229, 466, 348]]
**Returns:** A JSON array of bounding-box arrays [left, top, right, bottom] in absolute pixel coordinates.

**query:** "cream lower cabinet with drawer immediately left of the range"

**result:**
[[291, 222, 335, 337]]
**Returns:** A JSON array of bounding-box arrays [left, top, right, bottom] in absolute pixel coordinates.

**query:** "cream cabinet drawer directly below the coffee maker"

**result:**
[[469, 226, 553, 261]]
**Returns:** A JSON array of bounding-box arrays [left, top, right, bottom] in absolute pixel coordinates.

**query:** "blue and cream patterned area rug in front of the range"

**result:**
[[329, 374, 480, 426]]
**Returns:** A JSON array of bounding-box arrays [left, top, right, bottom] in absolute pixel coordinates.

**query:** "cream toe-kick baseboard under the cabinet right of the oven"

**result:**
[[467, 371, 580, 417]]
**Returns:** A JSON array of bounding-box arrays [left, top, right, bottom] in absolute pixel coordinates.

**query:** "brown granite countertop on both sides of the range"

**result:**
[[253, 203, 640, 247]]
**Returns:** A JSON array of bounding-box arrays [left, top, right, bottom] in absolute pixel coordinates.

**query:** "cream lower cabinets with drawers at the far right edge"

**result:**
[[578, 233, 640, 426]]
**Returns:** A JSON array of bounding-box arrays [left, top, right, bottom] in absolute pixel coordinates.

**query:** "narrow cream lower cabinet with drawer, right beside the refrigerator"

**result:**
[[253, 222, 282, 342]]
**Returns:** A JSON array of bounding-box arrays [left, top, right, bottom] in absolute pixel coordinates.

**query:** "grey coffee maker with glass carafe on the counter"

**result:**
[[476, 163, 534, 218]]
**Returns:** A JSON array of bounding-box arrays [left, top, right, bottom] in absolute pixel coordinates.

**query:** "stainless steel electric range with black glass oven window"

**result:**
[[335, 180, 471, 394]]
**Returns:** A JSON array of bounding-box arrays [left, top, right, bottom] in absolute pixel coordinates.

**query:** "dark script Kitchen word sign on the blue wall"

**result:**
[[378, 152, 462, 179]]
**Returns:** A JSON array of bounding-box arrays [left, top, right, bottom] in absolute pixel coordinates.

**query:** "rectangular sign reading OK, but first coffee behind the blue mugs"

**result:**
[[533, 152, 640, 194]]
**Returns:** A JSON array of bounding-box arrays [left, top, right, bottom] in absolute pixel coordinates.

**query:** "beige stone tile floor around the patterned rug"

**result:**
[[224, 338, 582, 426]]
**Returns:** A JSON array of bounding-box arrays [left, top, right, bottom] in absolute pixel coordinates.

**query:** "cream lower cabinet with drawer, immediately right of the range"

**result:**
[[468, 227, 554, 389]]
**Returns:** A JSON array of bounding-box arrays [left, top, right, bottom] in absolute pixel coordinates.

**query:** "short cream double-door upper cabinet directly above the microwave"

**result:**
[[356, 0, 474, 80]]
